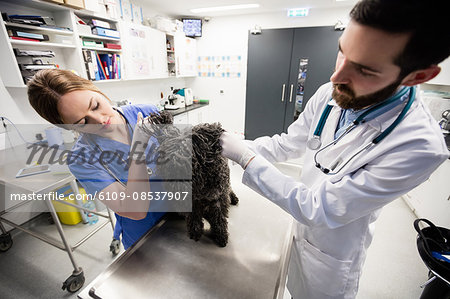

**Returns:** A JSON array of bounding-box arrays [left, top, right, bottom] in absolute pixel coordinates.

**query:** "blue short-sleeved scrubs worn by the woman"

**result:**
[[68, 105, 164, 249]]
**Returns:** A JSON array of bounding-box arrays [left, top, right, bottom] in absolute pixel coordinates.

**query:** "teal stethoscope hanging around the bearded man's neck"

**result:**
[[306, 87, 416, 175]]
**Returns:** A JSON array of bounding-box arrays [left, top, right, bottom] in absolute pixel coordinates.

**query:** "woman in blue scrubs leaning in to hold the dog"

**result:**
[[28, 69, 163, 249]]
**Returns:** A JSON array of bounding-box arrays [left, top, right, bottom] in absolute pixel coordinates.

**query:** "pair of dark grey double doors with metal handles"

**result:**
[[245, 26, 342, 140]]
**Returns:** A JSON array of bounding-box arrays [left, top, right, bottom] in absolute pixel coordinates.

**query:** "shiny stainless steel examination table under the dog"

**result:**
[[78, 190, 293, 299]]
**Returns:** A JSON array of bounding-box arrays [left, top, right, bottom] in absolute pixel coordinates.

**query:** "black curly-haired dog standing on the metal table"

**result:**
[[144, 111, 239, 247]]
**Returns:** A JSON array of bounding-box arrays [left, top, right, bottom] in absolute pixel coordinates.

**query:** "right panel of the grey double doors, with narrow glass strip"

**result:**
[[283, 26, 342, 131]]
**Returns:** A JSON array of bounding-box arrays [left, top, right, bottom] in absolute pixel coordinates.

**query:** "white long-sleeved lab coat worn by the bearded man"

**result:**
[[242, 83, 448, 299]]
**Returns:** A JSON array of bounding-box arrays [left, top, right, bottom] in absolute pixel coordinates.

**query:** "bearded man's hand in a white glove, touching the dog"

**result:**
[[220, 132, 255, 169]]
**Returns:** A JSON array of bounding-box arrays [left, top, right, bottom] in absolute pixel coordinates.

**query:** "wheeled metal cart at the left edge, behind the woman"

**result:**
[[0, 146, 120, 293]]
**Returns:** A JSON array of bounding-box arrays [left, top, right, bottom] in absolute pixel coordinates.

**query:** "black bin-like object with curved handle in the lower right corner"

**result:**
[[414, 219, 450, 299]]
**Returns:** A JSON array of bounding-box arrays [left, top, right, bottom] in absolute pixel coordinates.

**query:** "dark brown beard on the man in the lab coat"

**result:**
[[332, 80, 402, 110]]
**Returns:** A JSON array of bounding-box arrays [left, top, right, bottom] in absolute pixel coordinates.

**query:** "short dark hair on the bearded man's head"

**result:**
[[350, 0, 450, 77]]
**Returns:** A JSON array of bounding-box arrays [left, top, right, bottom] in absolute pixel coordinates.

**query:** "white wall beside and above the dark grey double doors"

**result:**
[[187, 6, 351, 134]]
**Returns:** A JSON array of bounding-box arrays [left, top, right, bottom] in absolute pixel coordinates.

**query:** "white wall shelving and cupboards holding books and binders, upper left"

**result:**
[[0, 0, 196, 88]]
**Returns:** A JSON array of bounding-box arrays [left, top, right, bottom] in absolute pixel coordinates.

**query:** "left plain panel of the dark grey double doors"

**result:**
[[245, 28, 294, 140]]
